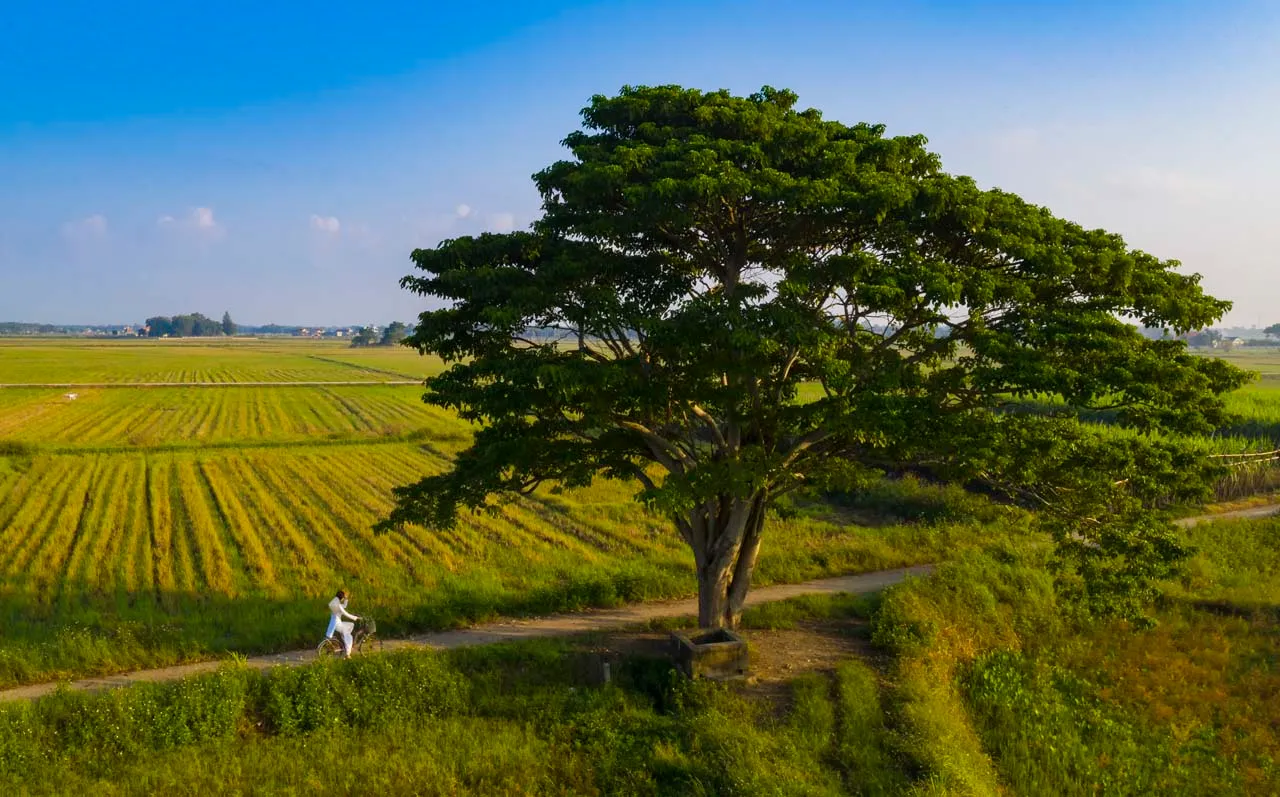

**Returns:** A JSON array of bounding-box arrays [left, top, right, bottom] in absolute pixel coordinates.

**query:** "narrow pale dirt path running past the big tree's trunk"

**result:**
[[0, 565, 932, 702]]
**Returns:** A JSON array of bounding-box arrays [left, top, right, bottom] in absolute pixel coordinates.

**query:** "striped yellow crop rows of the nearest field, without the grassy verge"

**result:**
[[0, 445, 680, 604]]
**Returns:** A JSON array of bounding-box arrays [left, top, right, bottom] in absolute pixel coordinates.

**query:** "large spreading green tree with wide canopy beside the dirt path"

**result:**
[[380, 86, 1243, 627]]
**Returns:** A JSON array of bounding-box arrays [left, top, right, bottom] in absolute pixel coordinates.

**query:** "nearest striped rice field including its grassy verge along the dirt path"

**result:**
[[0, 443, 952, 684]]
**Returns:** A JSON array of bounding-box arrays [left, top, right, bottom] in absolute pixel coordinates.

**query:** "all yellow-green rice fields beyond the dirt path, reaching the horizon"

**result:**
[[0, 340, 1280, 684]]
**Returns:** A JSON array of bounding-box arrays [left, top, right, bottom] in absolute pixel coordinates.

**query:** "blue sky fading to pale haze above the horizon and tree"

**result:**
[[0, 0, 1280, 325]]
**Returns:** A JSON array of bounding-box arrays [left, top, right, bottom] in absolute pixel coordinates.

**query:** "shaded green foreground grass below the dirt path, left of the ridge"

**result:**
[[0, 642, 906, 796]]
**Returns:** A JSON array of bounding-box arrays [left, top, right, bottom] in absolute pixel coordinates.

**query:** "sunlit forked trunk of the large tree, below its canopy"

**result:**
[[687, 495, 767, 628]]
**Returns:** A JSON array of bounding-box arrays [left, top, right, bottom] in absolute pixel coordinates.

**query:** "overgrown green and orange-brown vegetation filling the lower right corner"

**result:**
[[876, 519, 1280, 794]]
